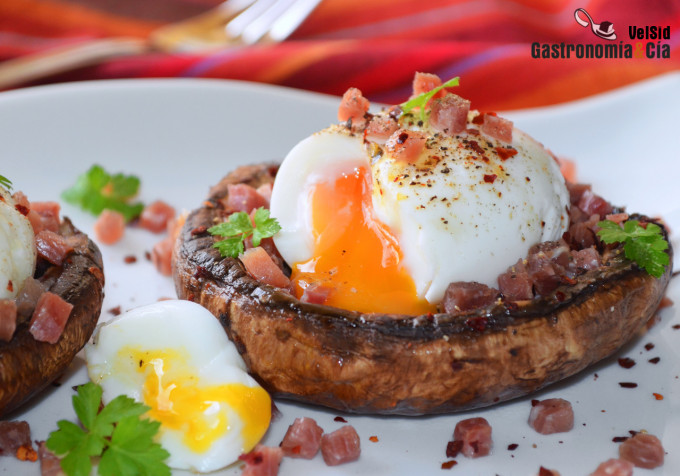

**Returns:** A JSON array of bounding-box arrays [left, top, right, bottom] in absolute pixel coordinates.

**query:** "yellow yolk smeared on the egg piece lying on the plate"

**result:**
[[131, 350, 271, 453]]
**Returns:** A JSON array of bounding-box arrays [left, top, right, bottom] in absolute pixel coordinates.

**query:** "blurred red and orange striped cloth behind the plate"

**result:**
[[0, 0, 680, 110]]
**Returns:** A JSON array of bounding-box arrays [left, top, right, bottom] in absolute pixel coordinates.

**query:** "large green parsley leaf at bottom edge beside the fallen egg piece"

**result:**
[[47, 382, 170, 476]]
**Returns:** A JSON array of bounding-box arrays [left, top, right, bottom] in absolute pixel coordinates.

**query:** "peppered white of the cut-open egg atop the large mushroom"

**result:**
[[271, 117, 569, 304]]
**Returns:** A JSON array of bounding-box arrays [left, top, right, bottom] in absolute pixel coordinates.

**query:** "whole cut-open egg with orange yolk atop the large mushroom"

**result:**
[[271, 113, 569, 314]]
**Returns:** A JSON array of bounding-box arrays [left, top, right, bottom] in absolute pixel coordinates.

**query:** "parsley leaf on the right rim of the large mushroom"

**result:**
[[597, 220, 670, 278]]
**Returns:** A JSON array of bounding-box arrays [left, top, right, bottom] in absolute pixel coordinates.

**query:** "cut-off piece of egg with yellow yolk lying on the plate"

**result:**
[[85, 300, 271, 472]]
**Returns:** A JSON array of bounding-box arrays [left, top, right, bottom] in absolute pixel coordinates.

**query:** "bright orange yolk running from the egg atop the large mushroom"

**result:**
[[291, 167, 435, 314]]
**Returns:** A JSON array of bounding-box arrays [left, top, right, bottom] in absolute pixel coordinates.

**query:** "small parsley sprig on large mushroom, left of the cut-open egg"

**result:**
[[208, 207, 281, 258]]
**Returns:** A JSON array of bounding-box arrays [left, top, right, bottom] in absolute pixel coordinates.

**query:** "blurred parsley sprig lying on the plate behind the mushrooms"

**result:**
[[61, 165, 144, 221]]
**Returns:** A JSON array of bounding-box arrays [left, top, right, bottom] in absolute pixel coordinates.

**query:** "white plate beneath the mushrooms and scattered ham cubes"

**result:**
[[0, 74, 680, 476]]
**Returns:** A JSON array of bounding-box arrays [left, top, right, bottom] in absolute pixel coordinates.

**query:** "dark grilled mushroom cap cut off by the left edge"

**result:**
[[0, 218, 104, 417]]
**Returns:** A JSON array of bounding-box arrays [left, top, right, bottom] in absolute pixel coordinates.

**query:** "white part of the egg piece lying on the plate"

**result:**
[[85, 300, 266, 472]]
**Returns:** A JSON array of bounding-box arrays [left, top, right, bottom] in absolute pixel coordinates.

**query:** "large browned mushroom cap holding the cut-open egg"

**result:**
[[173, 164, 671, 415]]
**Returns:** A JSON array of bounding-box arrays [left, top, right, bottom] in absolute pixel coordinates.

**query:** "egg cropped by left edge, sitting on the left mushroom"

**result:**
[[0, 186, 36, 299]]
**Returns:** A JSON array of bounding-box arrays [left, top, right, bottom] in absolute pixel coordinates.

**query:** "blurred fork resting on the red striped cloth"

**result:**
[[0, 0, 321, 90]]
